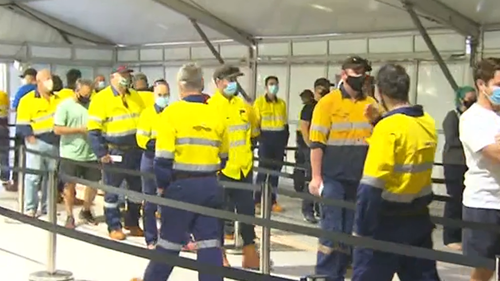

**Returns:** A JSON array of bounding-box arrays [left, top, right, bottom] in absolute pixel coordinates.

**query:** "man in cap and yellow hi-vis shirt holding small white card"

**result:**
[[87, 66, 144, 240]]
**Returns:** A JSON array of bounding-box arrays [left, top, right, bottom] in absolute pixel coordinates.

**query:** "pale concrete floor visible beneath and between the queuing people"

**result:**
[[0, 179, 469, 281]]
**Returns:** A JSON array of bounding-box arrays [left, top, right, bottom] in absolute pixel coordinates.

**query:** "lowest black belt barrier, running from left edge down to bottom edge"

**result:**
[[0, 207, 294, 281]]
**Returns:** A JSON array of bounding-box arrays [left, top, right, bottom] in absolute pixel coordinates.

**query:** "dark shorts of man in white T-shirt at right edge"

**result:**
[[462, 206, 500, 270]]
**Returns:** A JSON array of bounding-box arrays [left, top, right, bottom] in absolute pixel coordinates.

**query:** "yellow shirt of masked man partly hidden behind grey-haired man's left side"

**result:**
[[135, 105, 163, 156]]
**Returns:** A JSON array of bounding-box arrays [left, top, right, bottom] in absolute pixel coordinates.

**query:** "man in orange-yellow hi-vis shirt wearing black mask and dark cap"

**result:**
[[309, 57, 376, 281]]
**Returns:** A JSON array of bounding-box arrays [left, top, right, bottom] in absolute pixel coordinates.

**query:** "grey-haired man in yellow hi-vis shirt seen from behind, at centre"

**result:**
[[133, 64, 229, 281]]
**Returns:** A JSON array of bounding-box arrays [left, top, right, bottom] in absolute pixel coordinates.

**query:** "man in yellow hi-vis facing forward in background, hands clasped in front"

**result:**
[[254, 76, 290, 212]]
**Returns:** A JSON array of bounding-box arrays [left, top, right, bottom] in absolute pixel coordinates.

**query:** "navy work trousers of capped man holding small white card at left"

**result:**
[[103, 149, 142, 232]]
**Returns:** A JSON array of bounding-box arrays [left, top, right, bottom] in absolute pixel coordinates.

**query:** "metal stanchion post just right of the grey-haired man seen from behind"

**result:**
[[260, 176, 271, 274]]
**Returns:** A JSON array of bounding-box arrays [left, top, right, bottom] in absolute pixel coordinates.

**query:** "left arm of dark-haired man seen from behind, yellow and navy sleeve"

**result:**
[[353, 126, 397, 236]]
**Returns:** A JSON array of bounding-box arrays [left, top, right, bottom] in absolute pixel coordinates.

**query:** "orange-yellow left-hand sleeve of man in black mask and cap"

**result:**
[[309, 96, 332, 144]]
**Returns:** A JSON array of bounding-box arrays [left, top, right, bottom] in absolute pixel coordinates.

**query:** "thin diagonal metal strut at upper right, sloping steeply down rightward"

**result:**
[[404, 4, 458, 91]]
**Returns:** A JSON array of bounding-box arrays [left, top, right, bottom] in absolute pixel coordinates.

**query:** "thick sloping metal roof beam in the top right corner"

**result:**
[[401, 0, 481, 38]]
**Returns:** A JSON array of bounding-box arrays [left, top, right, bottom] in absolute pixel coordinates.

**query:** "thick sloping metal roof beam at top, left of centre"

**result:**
[[154, 0, 255, 47]]
